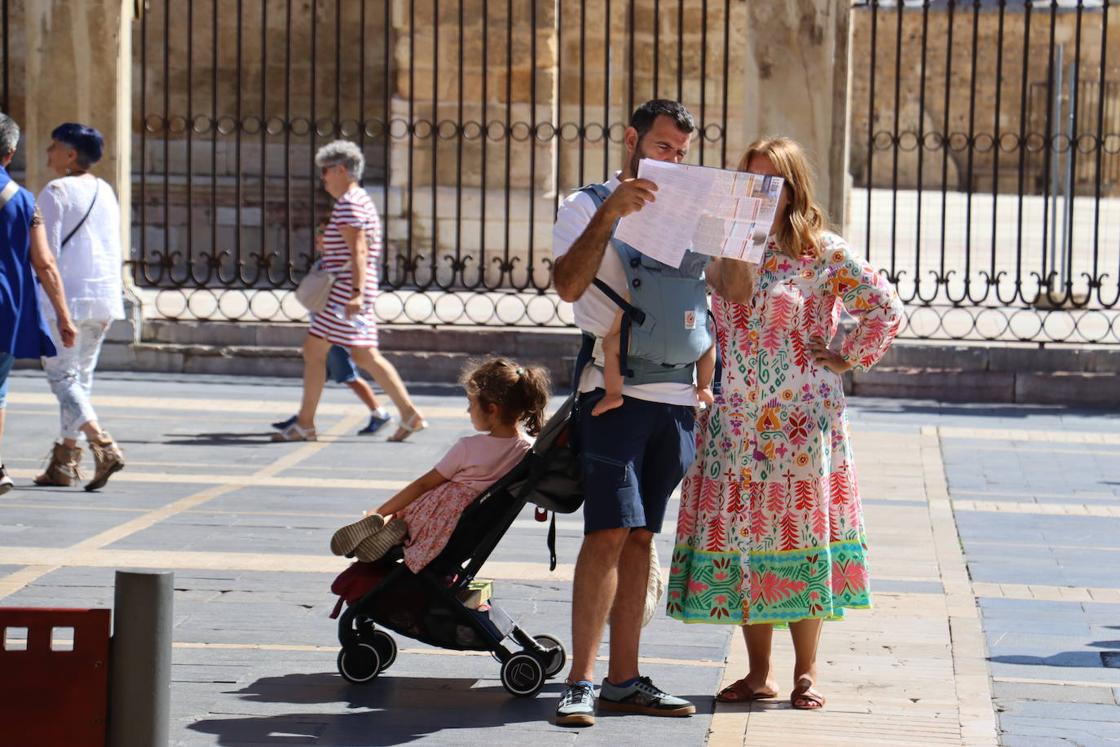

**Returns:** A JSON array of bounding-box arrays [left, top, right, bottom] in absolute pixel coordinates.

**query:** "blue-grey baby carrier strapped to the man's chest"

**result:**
[[580, 184, 715, 384]]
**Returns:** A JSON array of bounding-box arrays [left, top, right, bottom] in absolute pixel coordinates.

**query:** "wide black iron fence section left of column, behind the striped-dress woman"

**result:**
[[133, 0, 741, 325]]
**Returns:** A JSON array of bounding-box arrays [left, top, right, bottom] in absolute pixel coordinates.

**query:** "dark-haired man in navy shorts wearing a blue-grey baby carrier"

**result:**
[[552, 100, 768, 726]]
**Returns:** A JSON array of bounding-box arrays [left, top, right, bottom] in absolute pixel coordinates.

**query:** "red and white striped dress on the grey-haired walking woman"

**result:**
[[308, 187, 381, 347]]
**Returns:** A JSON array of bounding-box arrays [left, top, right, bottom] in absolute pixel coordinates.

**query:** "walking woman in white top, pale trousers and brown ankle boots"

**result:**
[[35, 122, 124, 491]]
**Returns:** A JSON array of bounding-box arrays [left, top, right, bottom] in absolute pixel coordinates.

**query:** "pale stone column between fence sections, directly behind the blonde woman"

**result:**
[[729, 0, 850, 226]]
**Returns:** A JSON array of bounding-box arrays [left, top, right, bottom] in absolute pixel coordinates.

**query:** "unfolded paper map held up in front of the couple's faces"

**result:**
[[615, 158, 783, 268]]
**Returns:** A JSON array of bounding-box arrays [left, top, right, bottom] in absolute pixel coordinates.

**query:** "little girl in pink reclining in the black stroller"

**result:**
[[330, 358, 551, 572]]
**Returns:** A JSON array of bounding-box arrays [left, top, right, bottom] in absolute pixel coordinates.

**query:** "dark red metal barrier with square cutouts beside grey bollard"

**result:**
[[0, 607, 110, 747]]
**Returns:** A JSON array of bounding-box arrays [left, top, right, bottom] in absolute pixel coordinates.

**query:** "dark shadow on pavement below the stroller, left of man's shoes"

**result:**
[[188, 672, 561, 745]]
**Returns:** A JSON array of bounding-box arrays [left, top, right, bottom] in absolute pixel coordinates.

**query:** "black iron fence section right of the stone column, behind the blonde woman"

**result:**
[[849, 0, 1120, 344]]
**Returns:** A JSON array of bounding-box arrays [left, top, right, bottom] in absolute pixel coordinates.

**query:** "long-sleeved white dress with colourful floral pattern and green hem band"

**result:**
[[668, 234, 903, 625]]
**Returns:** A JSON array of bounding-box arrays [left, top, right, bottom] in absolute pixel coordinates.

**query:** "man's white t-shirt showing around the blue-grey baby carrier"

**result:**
[[552, 174, 697, 407]]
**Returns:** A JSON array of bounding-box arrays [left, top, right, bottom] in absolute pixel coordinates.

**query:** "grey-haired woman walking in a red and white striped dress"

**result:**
[[272, 140, 428, 441]]
